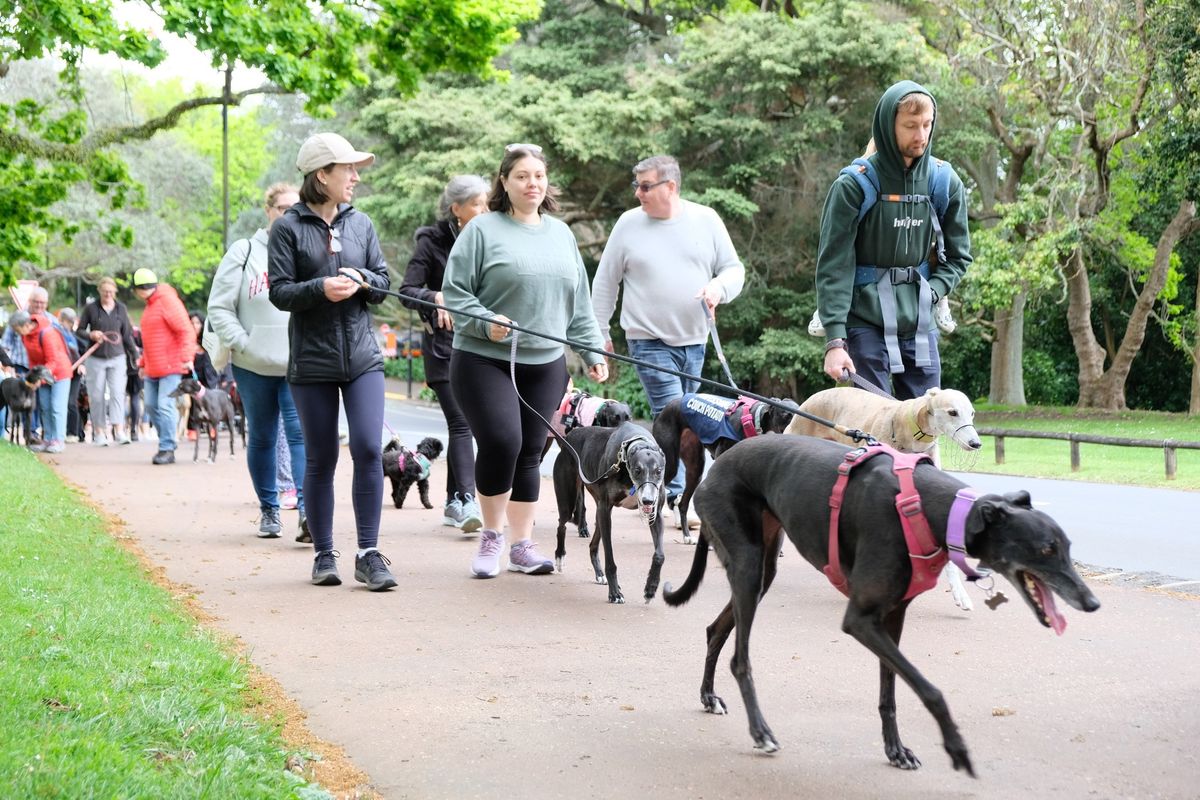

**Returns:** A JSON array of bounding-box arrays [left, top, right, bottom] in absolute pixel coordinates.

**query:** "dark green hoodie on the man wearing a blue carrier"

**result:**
[[817, 80, 971, 341]]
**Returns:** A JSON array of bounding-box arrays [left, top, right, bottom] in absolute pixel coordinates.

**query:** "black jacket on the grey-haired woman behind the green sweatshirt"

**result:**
[[400, 219, 458, 383]]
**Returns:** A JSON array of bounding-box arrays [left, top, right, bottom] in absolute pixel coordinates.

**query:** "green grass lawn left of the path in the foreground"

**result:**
[[0, 444, 328, 799]]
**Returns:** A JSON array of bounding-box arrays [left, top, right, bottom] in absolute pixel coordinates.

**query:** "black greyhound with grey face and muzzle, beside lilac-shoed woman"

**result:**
[[554, 422, 665, 603]]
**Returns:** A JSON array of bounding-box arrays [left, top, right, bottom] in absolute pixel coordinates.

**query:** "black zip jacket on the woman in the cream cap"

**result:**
[[268, 203, 390, 384]]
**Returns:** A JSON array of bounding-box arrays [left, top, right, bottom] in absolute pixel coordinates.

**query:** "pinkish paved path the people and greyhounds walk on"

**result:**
[[44, 441, 1200, 800]]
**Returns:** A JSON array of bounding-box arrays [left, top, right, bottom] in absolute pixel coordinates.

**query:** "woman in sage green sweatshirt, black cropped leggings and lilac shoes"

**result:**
[[442, 144, 608, 578]]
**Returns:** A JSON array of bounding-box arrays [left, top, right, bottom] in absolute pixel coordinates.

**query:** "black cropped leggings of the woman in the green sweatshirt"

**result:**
[[451, 350, 568, 503]]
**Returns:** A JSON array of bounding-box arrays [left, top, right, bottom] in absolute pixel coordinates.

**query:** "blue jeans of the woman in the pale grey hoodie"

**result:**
[[233, 365, 305, 510]]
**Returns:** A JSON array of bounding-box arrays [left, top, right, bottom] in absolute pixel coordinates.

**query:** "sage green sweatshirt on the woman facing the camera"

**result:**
[[442, 211, 604, 366]]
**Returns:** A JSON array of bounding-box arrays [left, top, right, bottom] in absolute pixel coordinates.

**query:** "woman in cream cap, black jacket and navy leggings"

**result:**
[[268, 133, 396, 591]]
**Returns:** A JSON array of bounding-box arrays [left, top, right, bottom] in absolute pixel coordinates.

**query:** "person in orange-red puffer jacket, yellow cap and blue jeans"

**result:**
[[133, 267, 196, 464]]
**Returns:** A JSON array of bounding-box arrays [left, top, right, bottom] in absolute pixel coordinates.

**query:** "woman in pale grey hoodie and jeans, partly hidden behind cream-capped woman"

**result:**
[[209, 184, 312, 542]]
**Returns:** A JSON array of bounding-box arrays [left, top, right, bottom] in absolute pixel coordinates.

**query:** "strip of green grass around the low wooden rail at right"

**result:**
[[942, 405, 1200, 492]]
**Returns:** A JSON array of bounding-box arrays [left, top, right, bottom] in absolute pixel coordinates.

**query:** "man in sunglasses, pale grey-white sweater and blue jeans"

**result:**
[[592, 156, 745, 525]]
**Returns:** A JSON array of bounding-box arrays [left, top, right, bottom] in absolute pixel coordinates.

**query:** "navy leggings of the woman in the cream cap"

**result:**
[[290, 372, 383, 553]]
